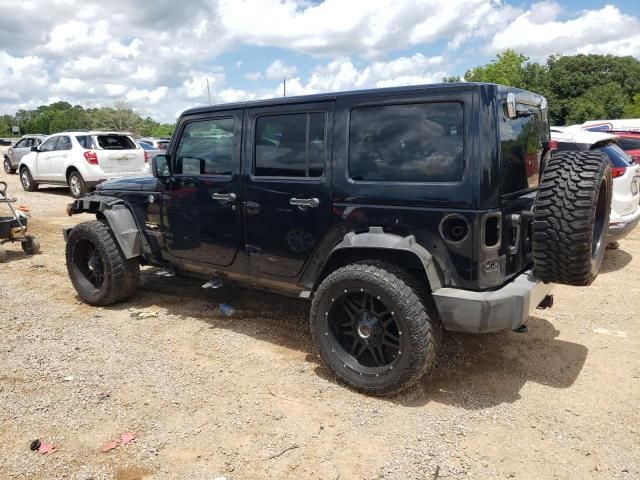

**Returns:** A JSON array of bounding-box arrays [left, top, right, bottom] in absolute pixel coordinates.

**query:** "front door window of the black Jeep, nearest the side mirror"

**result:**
[[176, 118, 234, 175]]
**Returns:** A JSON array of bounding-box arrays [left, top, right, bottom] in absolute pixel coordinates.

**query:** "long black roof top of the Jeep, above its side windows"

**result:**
[[182, 82, 544, 115]]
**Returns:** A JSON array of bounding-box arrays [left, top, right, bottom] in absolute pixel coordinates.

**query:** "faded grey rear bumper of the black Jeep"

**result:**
[[432, 270, 553, 333]]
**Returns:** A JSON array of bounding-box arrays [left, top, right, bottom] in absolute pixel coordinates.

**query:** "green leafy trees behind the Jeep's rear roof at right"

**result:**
[[443, 50, 640, 125]]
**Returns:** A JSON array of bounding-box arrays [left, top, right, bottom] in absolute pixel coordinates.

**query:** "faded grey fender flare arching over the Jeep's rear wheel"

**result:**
[[314, 227, 442, 290]]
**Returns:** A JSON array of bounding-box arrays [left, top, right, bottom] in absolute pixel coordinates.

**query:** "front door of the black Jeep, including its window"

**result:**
[[163, 110, 242, 267]]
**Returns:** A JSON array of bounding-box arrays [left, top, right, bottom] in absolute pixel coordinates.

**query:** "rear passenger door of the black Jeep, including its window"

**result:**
[[242, 103, 333, 278]]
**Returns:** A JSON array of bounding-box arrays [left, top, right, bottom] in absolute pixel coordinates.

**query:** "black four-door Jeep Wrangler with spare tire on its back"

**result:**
[[64, 83, 611, 395]]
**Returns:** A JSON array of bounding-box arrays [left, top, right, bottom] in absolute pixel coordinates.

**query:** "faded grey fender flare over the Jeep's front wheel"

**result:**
[[63, 195, 148, 259]]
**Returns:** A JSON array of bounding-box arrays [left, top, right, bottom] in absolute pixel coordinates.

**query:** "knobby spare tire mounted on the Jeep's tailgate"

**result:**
[[533, 151, 612, 286]]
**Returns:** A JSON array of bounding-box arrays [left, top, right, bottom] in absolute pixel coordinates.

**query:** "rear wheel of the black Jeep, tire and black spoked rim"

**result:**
[[310, 262, 440, 395]]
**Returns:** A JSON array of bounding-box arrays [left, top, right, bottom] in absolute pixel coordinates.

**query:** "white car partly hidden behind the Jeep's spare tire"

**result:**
[[551, 128, 640, 246]]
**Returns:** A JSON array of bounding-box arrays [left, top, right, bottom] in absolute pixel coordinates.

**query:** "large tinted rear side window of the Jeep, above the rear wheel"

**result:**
[[349, 102, 464, 182]]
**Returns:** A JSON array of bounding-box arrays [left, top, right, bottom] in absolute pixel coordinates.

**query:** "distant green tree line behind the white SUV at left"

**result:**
[[0, 101, 175, 137]]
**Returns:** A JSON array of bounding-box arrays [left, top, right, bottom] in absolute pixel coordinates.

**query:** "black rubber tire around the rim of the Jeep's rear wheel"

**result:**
[[310, 260, 441, 395]]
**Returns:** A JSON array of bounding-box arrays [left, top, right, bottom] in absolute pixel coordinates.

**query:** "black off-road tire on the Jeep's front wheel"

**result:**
[[66, 221, 140, 306]]
